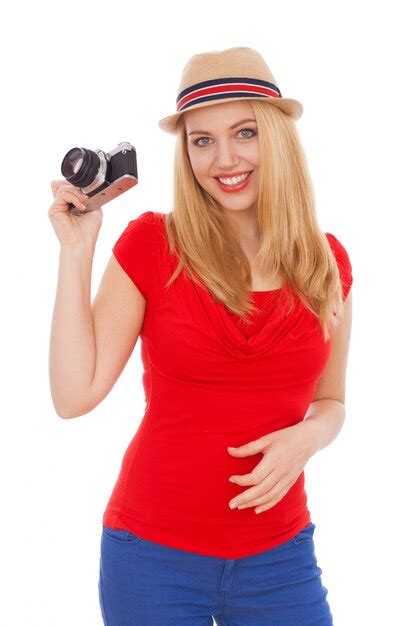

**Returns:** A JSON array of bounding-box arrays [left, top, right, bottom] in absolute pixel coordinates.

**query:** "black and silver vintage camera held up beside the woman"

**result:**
[[61, 141, 138, 216]]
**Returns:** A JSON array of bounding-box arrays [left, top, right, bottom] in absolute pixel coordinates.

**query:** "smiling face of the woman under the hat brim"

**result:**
[[184, 100, 259, 211]]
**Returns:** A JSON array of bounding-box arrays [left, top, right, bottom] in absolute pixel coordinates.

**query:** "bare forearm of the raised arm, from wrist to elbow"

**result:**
[[49, 241, 96, 417]]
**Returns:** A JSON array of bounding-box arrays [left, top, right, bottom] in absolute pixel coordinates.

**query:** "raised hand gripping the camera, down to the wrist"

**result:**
[[48, 178, 103, 246]]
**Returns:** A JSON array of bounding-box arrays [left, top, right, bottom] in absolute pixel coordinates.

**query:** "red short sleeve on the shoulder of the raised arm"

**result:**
[[112, 211, 159, 299]]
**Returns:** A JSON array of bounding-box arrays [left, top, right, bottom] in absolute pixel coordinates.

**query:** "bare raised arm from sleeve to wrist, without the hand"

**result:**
[[49, 245, 145, 418]]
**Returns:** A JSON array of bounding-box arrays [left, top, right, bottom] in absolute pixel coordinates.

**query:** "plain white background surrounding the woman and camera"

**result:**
[[0, 0, 417, 626]]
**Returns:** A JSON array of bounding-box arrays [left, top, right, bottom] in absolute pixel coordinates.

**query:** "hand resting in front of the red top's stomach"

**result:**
[[227, 422, 314, 513]]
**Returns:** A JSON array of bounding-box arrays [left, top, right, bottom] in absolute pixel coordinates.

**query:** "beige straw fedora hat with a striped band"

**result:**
[[158, 47, 303, 135]]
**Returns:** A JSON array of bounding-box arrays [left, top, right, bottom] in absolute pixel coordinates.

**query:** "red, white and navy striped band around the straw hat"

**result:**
[[176, 76, 282, 112]]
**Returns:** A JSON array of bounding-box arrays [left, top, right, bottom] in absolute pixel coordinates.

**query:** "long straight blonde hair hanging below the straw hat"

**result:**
[[165, 100, 343, 341]]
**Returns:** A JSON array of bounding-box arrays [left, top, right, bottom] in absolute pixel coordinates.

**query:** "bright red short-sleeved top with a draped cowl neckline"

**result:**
[[103, 211, 352, 559]]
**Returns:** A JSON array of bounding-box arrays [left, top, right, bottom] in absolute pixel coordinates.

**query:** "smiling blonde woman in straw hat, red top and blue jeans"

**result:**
[[51, 48, 352, 626]]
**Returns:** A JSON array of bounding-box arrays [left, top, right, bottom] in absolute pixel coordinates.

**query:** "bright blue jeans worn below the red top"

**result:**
[[98, 523, 333, 626]]
